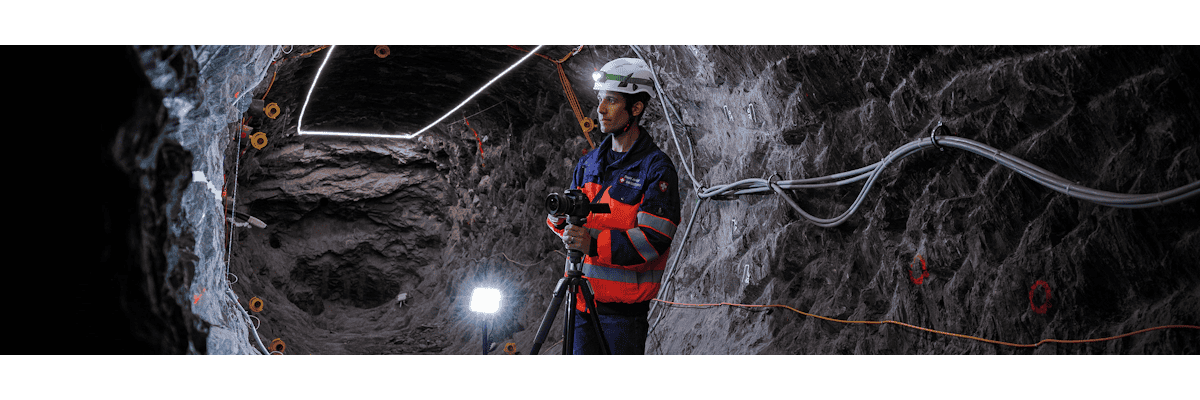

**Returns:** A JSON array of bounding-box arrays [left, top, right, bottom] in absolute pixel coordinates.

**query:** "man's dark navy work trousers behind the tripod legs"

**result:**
[[572, 306, 650, 354]]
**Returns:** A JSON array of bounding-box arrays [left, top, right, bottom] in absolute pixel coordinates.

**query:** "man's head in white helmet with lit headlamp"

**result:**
[[592, 59, 655, 135]]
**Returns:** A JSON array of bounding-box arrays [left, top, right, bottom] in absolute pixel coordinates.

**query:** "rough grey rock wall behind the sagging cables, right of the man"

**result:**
[[633, 47, 1200, 354]]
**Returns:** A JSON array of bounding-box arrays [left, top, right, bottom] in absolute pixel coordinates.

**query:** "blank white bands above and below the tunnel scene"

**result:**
[[0, 0, 1200, 399]]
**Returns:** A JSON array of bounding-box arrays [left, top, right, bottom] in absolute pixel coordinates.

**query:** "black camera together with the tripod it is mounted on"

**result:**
[[529, 189, 612, 356]]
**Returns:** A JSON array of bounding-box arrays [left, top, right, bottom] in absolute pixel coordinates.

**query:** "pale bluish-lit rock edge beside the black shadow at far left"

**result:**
[[132, 46, 280, 354]]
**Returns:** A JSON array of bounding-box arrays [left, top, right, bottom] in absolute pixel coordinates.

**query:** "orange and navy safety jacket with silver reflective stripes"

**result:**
[[546, 130, 679, 314]]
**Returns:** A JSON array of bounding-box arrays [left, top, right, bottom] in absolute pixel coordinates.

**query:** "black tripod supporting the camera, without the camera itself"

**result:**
[[529, 216, 612, 356]]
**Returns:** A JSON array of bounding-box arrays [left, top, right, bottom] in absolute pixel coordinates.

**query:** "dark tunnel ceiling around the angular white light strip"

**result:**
[[267, 46, 556, 133]]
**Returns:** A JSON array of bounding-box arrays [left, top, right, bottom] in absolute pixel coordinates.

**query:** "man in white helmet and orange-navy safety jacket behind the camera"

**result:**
[[546, 59, 679, 354]]
